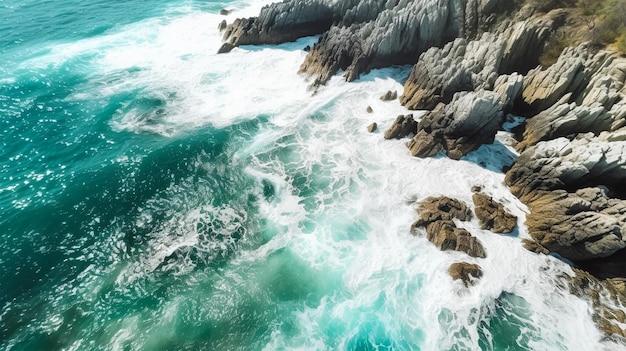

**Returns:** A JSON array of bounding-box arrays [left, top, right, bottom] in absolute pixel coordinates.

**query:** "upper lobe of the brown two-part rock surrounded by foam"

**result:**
[[413, 196, 472, 227]]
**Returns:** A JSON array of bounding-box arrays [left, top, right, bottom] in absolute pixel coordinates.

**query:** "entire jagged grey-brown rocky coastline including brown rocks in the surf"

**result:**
[[220, 0, 626, 341]]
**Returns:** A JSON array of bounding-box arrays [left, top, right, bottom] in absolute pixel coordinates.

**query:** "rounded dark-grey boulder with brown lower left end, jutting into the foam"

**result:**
[[408, 90, 504, 159]]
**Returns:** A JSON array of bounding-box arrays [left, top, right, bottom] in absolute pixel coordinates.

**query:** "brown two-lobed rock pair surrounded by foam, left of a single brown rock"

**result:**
[[411, 196, 486, 258]]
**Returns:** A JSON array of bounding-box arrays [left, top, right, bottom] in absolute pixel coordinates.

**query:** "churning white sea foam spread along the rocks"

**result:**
[[17, 2, 620, 350]]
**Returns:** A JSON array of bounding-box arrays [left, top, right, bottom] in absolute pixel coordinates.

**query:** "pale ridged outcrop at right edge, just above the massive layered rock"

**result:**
[[518, 44, 626, 151]]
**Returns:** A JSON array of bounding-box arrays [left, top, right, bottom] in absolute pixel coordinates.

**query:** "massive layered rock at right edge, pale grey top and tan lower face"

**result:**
[[505, 132, 626, 276]]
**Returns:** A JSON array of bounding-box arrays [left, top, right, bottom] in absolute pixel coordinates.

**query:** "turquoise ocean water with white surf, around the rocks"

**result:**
[[0, 0, 615, 351]]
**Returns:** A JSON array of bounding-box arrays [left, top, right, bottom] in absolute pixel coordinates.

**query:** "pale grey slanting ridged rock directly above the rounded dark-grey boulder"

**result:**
[[400, 12, 557, 110]]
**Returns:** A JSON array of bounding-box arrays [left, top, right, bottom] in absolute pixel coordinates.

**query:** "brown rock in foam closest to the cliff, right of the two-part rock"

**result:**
[[472, 194, 517, 233]]
